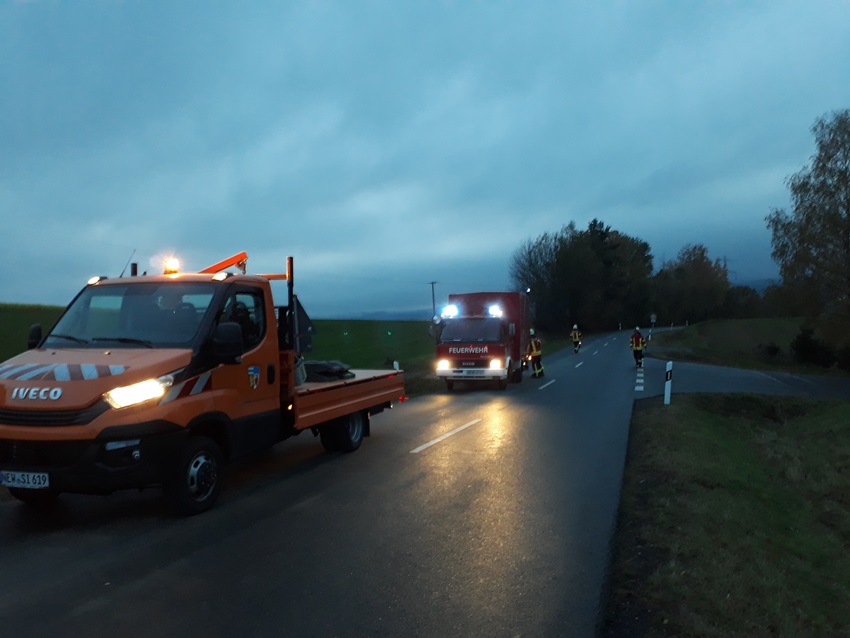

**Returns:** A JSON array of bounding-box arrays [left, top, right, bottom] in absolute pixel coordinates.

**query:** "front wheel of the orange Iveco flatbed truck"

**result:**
[[165, 436, 224, 516]]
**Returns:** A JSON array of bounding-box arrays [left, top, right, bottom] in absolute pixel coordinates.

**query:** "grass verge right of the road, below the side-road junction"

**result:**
[[602, 394, 850, 637]]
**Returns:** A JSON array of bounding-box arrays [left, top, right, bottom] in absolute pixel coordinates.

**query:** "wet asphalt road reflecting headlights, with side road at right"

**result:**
[[0, 332, 850, 638]]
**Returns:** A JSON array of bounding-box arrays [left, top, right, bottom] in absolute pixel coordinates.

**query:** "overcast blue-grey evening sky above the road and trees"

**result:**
[[0, 0, 850, 318]]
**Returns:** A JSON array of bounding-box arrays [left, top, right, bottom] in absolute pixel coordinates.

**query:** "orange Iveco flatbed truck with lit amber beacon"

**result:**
[[0, 252, 406, 515]]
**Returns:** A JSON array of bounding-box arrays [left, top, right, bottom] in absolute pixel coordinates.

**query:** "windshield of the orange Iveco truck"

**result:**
[[44, 282, 215, 348]]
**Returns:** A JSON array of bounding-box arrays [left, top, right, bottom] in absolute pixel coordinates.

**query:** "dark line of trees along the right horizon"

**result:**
[[510, 110, 850, 342]]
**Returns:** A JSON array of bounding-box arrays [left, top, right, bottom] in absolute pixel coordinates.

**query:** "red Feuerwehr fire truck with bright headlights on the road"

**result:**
[[434, 292, 531, 390]]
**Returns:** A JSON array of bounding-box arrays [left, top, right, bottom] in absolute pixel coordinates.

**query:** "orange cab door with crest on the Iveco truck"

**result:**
[[213, 286, 280, 455]]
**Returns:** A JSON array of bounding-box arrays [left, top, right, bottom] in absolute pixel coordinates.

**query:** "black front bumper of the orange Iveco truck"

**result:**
[[0, 421, 187, 494]]
